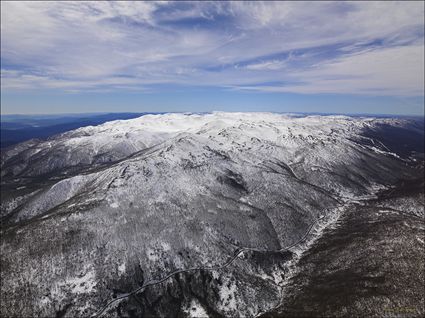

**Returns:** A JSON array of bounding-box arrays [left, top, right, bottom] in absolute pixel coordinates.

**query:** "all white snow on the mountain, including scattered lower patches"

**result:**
[[0, 112, 418, 317]]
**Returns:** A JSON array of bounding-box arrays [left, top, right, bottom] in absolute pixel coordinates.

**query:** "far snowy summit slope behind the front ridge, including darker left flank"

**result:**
[[2, 113, 406, 176]]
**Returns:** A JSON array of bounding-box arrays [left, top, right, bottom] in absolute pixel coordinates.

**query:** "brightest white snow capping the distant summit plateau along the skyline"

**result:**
[[7, 112, 404, 170]]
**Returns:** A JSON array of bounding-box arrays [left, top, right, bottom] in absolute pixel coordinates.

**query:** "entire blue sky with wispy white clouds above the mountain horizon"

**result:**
[[1, 1, 424, 115]]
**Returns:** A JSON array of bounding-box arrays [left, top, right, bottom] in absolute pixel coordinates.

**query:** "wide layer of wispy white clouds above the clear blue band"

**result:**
[[1, 1, 424, 96]]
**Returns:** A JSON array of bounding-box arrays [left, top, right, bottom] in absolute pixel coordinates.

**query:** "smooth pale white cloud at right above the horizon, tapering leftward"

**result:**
[[250, 45, 425, 96]]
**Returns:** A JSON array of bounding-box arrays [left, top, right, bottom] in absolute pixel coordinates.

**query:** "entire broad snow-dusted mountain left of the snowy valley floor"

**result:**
[[0, 113, 423, 317]]
